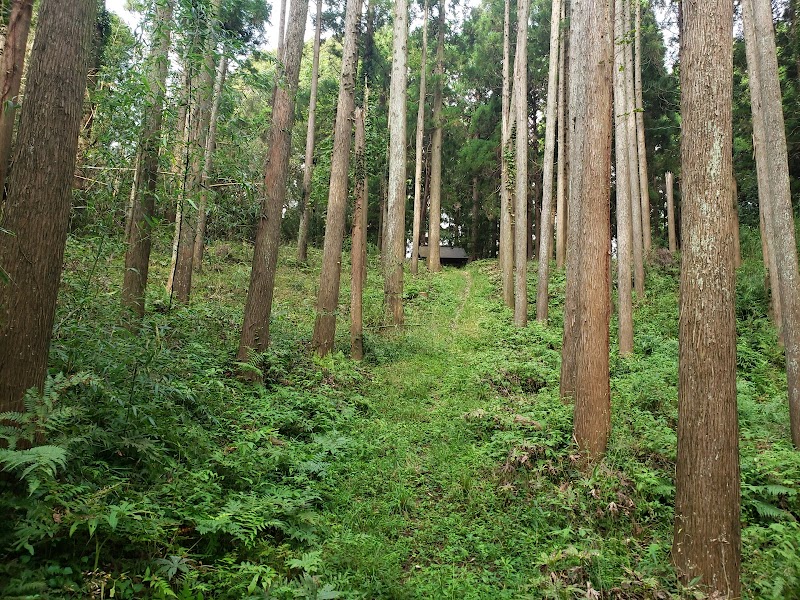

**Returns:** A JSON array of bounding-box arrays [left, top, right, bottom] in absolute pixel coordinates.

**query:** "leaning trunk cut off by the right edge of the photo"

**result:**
[[744, 0, 800, 448]]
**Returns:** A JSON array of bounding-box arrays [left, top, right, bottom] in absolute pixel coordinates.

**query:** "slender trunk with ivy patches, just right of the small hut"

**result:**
[[497, 0, 514, 308]]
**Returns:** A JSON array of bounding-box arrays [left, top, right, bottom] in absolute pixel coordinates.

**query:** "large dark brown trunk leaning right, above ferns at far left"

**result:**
[[0, 0, 97, 412]]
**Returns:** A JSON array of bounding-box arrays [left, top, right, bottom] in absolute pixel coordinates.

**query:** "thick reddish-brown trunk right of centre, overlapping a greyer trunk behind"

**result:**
[[570, 2, 614, 462]]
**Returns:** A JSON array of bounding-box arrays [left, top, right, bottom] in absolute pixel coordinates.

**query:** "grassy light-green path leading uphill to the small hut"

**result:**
[[318, 268, 568, 598]]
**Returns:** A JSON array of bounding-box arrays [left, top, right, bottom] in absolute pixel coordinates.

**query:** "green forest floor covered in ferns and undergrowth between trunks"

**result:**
[[0, 236, 800, 600]]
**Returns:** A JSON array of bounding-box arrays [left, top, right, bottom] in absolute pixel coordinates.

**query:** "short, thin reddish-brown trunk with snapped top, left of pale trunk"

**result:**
[[350, 107, 368, 360]]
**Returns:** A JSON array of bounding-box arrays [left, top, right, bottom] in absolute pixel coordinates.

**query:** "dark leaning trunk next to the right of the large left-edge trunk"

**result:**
[[122, 0, 173, 329]]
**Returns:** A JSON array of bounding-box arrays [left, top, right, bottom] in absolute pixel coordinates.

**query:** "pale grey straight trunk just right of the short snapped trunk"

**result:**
[[383, 0, 408, 325]]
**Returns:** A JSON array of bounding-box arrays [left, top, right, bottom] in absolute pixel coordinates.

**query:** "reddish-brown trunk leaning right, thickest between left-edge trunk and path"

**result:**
[[237, 0, 308, 361]]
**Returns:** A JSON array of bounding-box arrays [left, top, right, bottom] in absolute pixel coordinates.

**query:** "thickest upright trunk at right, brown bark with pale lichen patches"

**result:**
[[672, 0, 741, 598]]
